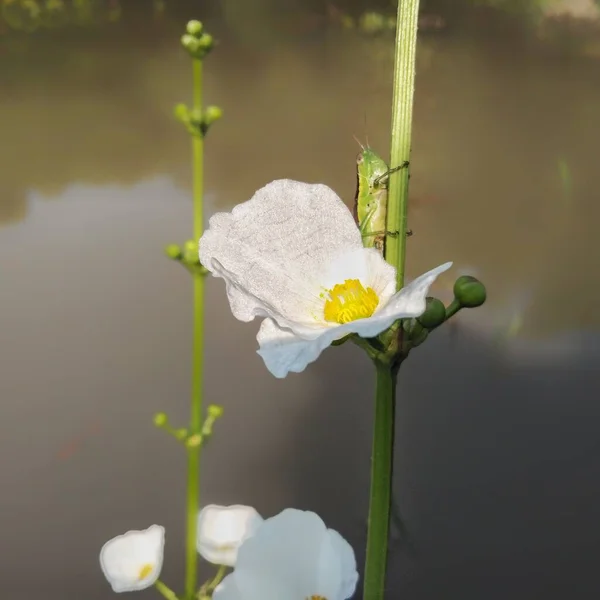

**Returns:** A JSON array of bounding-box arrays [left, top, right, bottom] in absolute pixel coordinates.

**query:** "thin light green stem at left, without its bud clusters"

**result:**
[[185, 59, 204, 600]]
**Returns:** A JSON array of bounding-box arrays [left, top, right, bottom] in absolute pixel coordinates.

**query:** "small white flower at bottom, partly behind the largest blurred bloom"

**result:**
[[196, 504, 263, 567]]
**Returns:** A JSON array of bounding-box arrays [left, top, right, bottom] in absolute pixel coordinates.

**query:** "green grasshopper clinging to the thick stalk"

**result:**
[[354, 144, 412, 254]]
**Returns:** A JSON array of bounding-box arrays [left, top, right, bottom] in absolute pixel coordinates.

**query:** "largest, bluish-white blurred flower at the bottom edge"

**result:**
[[213, 508, 358, 600]]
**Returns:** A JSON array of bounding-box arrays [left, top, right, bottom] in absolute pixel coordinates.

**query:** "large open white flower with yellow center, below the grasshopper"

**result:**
[[200, 179, 452, 377]]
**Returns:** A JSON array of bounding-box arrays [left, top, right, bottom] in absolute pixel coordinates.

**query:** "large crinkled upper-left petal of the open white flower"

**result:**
[[199, 179, 362, 325]]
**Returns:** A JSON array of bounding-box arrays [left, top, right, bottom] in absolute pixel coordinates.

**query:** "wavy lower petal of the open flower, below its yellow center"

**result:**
[[257, 262, 452, 378]]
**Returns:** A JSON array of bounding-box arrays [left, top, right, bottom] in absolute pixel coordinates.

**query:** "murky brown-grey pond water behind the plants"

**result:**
[[0, 5, 600, 600]]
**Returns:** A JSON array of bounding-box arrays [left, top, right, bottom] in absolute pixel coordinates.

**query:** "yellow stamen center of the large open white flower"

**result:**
[[324, 279, 379, 326]]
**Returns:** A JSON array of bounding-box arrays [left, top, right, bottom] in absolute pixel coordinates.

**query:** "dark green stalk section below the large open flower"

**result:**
[[363, 360, 397, 600]]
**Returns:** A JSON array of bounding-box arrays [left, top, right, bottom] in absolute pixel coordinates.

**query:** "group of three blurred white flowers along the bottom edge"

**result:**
[[100, 505, 358, 600]]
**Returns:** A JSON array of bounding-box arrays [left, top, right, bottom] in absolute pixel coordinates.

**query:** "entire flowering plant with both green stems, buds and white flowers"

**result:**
[[100, 0, 486, 600]]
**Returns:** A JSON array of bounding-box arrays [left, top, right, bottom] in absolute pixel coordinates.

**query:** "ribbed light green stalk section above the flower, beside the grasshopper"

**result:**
[[386, 0, 419, 289]]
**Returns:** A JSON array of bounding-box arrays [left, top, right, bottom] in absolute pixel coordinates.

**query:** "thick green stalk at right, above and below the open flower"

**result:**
[[363, 0, 419, 600]]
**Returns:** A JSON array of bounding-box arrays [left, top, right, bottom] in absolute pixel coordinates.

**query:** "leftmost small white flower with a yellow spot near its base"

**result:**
[[100, 525, 165, 592]]
